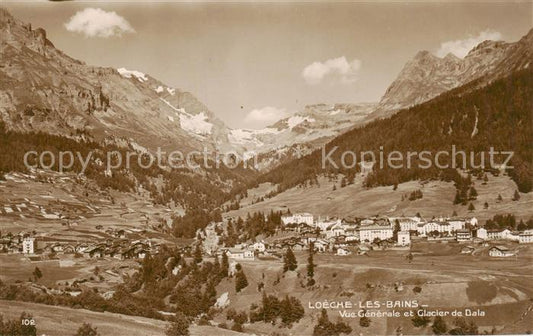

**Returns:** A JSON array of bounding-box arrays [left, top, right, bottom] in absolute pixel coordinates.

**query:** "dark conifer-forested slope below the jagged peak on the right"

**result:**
[[257, 69, 533, 192]]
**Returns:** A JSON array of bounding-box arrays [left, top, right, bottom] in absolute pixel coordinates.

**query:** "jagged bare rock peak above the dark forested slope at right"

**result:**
[[370, 30, 533, 118]]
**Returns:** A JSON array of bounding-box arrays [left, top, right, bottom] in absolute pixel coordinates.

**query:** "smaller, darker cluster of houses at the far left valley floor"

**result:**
[[0, 231, 159, 260]]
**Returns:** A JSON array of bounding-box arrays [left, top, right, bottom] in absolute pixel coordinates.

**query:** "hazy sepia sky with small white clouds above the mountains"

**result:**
[[2, 1, 533, 128]]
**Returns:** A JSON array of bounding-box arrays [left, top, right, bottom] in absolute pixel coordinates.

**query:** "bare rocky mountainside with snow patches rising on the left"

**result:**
[[0, 9, 231, 150]]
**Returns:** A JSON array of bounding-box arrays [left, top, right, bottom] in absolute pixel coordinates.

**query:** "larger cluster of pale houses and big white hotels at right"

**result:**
[[218, 213, 533, 260]]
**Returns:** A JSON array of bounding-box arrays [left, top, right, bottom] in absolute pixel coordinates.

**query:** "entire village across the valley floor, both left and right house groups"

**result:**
[[0, 209, 533, 261]]
